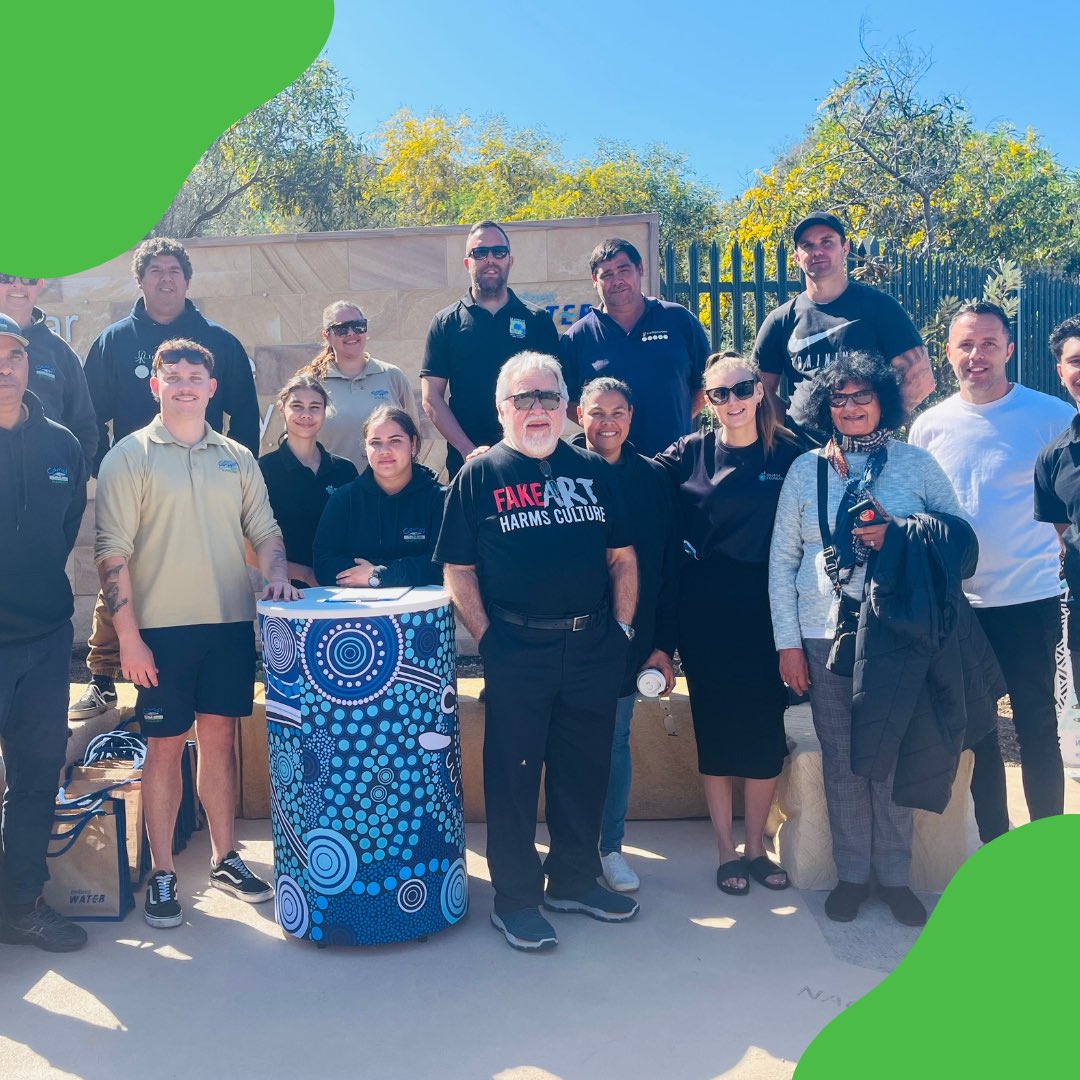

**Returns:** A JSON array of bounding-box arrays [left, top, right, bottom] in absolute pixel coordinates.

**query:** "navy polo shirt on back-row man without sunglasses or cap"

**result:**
[[559, 296, 708, 457]]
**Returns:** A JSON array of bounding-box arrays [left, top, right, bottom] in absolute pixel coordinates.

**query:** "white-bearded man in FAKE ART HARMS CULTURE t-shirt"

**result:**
[[435, 352, 647, 951]]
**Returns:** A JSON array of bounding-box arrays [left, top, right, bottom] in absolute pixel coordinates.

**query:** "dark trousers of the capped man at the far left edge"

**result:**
[[0, 622, 72, 905]]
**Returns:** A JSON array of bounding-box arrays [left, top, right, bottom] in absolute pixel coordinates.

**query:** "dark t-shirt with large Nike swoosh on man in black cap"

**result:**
[[754, 281, 922, 423]]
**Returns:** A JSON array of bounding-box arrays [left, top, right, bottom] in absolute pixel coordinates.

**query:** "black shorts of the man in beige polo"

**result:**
[[135, 622, 255, 739]]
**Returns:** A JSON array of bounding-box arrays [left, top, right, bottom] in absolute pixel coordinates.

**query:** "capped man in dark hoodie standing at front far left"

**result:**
[[0, 314, 86, 953]]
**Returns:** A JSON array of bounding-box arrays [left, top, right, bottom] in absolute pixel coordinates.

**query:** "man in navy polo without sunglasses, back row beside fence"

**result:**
[[559, 239, 708, 457]]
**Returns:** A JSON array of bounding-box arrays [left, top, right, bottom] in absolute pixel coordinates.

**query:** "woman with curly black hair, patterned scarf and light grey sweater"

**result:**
[[769, 352, 963, 926]]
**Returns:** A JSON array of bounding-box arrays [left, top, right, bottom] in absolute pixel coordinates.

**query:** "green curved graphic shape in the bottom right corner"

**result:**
[[795, 815, 1080, 1080]]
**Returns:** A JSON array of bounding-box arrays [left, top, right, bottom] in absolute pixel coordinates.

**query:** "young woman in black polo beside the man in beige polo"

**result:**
[[259, 374, 356, 588]]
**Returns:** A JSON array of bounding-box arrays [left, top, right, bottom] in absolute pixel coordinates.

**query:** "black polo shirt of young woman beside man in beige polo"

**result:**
[[259, 440, 356, 566]]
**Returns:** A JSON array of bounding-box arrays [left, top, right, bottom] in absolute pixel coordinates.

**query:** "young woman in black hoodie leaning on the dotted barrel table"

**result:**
[[313, 405, 446, 589]]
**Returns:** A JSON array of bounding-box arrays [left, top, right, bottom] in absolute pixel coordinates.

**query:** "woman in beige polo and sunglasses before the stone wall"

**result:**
[[301, 300, 420, 472]]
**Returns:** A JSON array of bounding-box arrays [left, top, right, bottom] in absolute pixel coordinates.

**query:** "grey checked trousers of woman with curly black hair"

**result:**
[[802, 638, 912, 886]]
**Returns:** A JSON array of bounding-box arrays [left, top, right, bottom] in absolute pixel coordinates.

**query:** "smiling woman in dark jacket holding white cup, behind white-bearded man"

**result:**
[[573, 376, 680, 892]]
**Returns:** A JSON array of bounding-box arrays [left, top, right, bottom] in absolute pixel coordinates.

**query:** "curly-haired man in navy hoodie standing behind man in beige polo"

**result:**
[[69, 237, 259, 719]]
